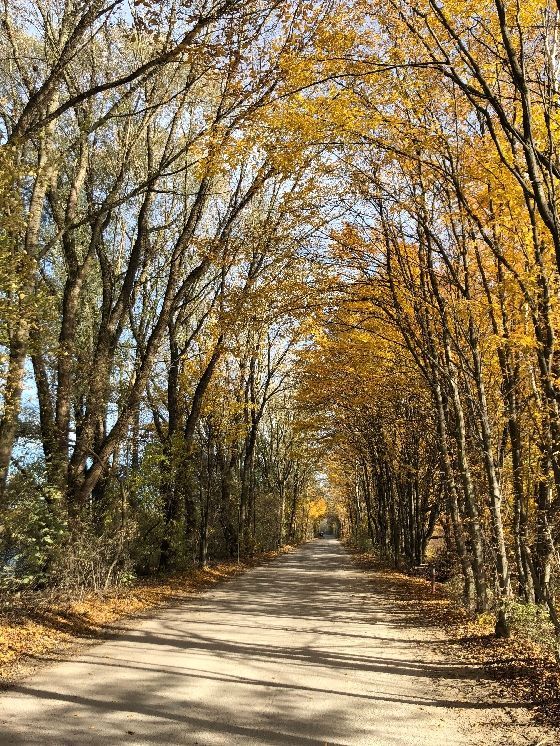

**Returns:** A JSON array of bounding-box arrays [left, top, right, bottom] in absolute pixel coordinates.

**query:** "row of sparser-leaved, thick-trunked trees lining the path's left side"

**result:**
[[0, 0, 332, 586]]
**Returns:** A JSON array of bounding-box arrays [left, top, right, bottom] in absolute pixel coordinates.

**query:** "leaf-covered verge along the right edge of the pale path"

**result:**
[[348, 547, 560, 727]]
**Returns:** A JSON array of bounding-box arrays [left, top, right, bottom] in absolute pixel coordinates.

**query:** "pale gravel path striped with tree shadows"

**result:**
[[0, 540, 553, 746]]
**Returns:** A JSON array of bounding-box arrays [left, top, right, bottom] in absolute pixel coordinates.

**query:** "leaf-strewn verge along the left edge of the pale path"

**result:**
[[0, 547, 289, 684]]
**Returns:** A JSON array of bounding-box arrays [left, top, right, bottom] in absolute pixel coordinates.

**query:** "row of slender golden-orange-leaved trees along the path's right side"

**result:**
[[298, 0, 560, 640]]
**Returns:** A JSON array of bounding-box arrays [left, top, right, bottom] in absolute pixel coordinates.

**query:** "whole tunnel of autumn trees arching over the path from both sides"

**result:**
[[0, 0, 560, 640]]
